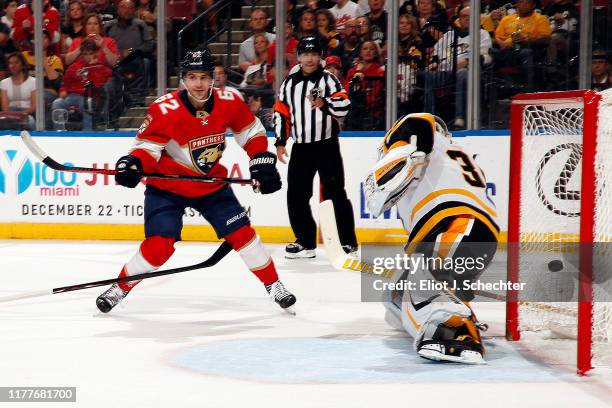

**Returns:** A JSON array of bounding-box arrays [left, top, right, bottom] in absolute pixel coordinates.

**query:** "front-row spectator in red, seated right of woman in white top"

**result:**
[[51, 39, 113, 131]]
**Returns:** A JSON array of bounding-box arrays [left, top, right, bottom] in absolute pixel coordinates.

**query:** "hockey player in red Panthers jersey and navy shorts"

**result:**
[[96, 50, 296, 313]]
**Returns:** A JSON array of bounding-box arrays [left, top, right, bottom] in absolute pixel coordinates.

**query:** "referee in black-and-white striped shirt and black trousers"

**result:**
[[274, 37, 357, 258]]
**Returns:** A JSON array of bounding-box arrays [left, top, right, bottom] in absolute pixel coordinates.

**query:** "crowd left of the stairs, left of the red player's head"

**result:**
[[0, 0, 156, 130]]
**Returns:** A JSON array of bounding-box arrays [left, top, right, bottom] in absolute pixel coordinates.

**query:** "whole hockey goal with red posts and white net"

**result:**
[[507, 91, 612, 373]]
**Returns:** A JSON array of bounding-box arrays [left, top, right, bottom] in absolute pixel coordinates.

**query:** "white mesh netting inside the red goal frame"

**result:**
[[519, 92, 612, 366]]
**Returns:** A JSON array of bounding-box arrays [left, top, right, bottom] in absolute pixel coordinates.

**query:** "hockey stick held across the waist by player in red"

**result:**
[[21, 130, 256, 185]]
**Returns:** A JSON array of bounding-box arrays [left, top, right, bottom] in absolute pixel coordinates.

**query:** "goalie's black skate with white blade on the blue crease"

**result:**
[[417, 336, 487, 364]]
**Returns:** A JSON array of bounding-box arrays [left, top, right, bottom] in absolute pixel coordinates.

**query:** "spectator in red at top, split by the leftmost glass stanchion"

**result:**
[[12, 0, 61, 51]]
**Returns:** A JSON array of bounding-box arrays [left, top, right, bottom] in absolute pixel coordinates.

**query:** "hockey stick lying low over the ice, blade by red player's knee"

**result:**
[[0, 241, 232, 303]]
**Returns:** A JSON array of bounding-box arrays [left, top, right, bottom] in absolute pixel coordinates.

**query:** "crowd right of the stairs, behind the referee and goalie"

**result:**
[[231, 0, 612, 130]]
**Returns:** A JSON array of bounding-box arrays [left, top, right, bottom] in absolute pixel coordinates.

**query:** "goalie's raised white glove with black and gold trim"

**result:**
[[365, 144, 426, 218]]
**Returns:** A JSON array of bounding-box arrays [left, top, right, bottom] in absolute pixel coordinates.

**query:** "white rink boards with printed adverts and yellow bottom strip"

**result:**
[[0, 131, 510, 242]]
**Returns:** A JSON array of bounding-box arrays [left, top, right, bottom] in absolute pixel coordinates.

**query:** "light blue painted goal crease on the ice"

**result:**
[[175, 336, 575, 384]]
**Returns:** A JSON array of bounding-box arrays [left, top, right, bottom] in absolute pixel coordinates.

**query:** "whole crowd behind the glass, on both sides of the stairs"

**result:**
[[0, 0, 612, 130]]
